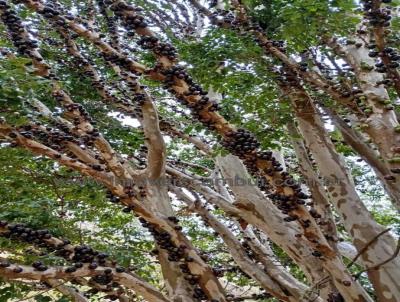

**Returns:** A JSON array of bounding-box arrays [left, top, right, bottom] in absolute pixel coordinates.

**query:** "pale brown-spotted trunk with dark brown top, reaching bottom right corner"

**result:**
[[287, 83, 400, 302]]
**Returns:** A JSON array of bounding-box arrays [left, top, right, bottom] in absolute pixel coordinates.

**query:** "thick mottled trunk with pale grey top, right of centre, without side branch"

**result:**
[[217, 155, 325, 282]]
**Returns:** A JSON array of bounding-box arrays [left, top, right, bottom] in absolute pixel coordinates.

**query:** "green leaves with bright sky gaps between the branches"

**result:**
[[0, 0, 400, 302]]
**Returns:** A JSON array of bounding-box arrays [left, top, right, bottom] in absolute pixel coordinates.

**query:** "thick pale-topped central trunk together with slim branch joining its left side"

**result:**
[[167, 162, 324, 282]]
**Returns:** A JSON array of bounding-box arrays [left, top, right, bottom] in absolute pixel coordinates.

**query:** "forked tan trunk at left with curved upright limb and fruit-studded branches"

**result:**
[[0, 2, 225, 301]]
